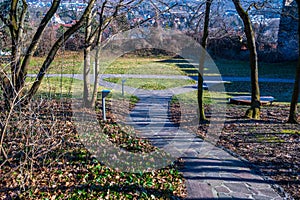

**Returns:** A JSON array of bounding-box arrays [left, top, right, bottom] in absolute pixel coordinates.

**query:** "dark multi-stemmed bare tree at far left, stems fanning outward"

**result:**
[[0, 0, 96, 107]]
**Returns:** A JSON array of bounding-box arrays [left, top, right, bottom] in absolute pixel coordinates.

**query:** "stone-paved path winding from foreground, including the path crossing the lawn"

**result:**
[[29, 75, 291, 200]]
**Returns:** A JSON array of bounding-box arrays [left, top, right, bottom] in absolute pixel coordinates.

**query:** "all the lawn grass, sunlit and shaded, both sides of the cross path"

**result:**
[[2, 52, 297, 102]]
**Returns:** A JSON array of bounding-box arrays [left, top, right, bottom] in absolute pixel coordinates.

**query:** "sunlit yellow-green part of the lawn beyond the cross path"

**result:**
[[29, 52, 185, 75]]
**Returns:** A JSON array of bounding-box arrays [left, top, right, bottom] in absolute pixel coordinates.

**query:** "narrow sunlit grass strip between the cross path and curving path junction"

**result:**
[[104, 78, 196, 90]]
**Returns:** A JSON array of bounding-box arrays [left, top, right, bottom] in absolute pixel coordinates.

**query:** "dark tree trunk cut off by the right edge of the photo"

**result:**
[[288, 0, 300, 123]]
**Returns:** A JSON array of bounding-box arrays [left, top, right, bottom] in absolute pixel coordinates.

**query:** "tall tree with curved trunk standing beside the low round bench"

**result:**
[[232, 0, 260, 119]]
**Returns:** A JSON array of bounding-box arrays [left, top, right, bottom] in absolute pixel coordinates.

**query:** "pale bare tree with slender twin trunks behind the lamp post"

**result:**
[[83, 0, 142, 107]]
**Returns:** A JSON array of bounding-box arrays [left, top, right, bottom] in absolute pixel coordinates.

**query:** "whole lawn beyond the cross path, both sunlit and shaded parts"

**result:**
[[25, 51, 297, 79]]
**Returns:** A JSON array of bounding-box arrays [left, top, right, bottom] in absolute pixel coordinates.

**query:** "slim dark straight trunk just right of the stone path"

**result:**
[[197, 0, 212, 123]]
